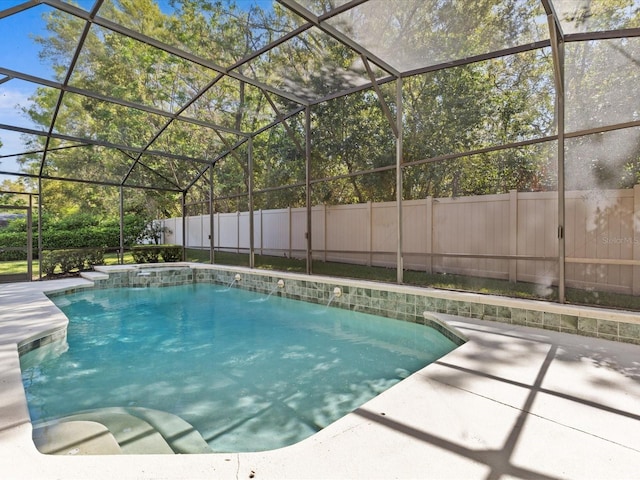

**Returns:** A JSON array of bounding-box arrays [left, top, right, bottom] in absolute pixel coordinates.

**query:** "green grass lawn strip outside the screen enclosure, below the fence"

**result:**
[[0, 249, 640, 311]]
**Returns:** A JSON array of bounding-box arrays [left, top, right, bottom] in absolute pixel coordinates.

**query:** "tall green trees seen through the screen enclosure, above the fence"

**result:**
[[3, 0, 640, 223]]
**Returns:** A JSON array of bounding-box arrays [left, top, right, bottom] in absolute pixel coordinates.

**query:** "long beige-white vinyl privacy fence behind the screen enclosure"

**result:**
[[164, 186, 640, 294]]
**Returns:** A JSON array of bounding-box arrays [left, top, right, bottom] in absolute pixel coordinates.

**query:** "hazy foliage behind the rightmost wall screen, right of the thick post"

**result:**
[[565, 36, 640, 190]]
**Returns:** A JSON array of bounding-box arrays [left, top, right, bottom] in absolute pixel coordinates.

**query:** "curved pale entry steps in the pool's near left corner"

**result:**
[[34, 407, 211, 454]]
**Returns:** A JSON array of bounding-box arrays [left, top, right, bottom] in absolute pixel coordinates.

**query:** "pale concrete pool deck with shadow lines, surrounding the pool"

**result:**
[[0, 279, 640, 480]]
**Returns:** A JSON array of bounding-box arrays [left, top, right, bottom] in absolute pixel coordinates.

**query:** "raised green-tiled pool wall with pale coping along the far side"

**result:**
[[46, 264, 640, 345]]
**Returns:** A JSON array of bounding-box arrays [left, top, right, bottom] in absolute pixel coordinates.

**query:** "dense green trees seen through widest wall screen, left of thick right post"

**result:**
[[404, 47, 554, 198]]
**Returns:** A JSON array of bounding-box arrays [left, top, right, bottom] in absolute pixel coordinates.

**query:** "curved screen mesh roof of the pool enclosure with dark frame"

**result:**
[[0, 0, 640, 191]]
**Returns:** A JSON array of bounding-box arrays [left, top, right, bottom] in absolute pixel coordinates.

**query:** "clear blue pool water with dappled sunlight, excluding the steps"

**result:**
[[21, 284, 456, 452]]
